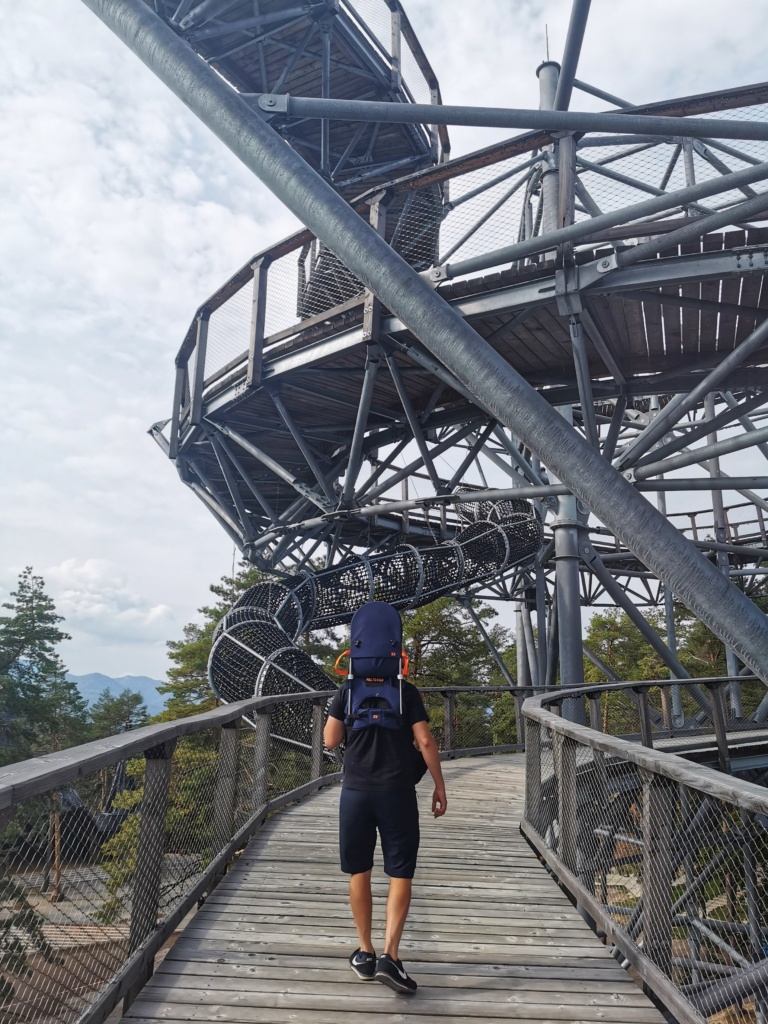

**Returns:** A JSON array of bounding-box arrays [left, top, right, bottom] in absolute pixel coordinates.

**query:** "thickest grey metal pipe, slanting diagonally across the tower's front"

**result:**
[[83, 0, 768, 679]]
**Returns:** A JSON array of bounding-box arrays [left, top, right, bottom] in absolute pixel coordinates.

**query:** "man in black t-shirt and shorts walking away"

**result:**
[[324, 602, 446, 994]]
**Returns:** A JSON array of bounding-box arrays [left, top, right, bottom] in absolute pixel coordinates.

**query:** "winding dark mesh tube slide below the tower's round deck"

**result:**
[[208, 500, 542, 748]]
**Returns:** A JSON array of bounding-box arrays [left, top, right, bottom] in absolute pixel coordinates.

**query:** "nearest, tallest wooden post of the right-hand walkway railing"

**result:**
[[640, 769, 675, 971]]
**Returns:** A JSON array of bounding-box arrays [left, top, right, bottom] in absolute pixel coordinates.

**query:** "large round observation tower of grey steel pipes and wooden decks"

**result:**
[[85, 0, 768, 729]]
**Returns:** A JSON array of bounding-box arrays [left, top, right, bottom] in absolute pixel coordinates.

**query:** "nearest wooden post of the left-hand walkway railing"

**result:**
[[123, 739, 176, 1013]]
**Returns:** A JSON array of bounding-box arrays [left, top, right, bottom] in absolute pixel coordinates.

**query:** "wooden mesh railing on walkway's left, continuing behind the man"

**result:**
[[0, 681, 527, 1024]]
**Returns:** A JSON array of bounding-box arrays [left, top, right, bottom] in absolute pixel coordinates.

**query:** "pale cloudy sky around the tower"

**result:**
[[0, 0, 768, 678]]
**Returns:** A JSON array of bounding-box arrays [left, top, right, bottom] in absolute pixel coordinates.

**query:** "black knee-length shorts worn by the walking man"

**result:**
[[339, 786, 419, 879]]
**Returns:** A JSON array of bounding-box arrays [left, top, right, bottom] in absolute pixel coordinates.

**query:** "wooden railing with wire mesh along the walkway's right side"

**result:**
[[521, 680, 768, 1024]]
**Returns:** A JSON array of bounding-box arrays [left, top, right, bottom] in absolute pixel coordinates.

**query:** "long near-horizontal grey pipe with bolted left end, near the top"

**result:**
[[257, 91, 768, 142]]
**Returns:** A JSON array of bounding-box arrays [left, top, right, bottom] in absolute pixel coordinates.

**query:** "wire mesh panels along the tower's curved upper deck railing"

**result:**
[[169, 90, 768, 434]]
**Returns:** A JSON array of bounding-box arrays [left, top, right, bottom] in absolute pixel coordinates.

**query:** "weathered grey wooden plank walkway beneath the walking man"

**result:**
[[125, 755, 664, 1024]]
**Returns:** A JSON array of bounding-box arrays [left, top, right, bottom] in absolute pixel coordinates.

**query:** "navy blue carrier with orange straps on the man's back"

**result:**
[[337, 601, 408, 729]]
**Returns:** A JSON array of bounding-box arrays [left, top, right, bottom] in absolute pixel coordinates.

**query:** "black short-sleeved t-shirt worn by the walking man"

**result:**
[[328, 683, 429, 790]]
